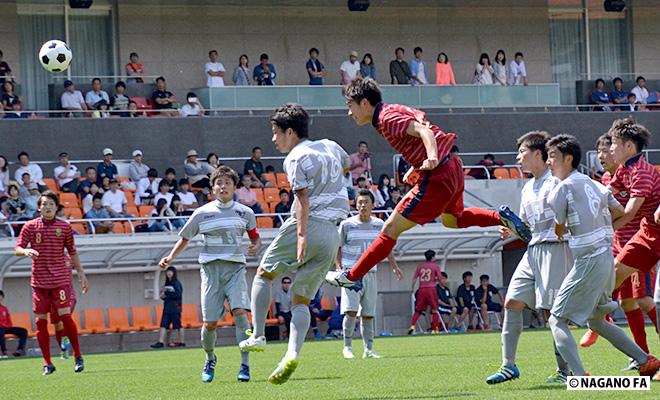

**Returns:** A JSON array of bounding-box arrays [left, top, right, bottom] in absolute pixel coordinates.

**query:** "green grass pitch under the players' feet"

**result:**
[[0, 327, 660, 400]]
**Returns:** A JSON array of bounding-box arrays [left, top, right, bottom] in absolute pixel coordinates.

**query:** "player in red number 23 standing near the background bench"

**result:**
[[408, 250, 440, 335]]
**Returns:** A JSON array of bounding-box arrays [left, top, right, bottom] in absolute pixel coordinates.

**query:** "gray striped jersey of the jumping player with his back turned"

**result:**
[[284, 139, 349, 221]]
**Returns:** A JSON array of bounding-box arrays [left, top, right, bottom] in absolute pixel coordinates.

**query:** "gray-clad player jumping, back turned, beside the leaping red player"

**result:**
[[240, 104, 360, 384]]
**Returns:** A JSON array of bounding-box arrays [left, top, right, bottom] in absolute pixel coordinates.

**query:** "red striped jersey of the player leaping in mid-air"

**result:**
[[371, 103, 457, 169]]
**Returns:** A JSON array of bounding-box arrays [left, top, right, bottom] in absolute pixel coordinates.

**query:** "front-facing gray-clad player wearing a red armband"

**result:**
[[159, 166, 261, 383]]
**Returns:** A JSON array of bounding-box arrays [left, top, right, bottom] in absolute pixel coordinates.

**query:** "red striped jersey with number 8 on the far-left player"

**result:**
[[16, 218, 77, 289]]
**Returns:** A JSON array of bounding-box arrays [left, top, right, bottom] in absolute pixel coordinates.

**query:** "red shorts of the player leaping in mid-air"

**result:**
[[396, 157, 463, 225]]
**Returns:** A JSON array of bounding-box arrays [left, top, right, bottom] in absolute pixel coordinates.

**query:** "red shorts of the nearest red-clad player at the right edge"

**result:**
[[616, 218, 660, 272]]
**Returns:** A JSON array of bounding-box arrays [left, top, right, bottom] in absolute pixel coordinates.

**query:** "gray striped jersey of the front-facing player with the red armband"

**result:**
[[179, 200, 257, 264]]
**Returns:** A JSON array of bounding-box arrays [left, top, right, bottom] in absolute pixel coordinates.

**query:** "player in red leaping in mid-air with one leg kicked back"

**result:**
[[326, 78, 530, 286]]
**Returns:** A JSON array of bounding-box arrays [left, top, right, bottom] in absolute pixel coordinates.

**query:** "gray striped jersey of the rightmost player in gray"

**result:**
[[548, 171, 619, 259]]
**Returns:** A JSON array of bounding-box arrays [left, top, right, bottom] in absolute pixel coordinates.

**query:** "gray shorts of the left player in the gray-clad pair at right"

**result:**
[[506, 242, 573, 310]]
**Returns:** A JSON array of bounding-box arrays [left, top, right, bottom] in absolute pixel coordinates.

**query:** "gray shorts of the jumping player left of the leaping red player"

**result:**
[[261, 218, 339, 299]]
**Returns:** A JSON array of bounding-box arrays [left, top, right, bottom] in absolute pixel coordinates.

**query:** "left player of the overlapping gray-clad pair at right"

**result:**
[[486, 131, 573, 385]]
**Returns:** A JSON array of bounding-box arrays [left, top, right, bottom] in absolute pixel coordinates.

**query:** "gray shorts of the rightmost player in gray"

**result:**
[[551, 249, 615, 326]]
